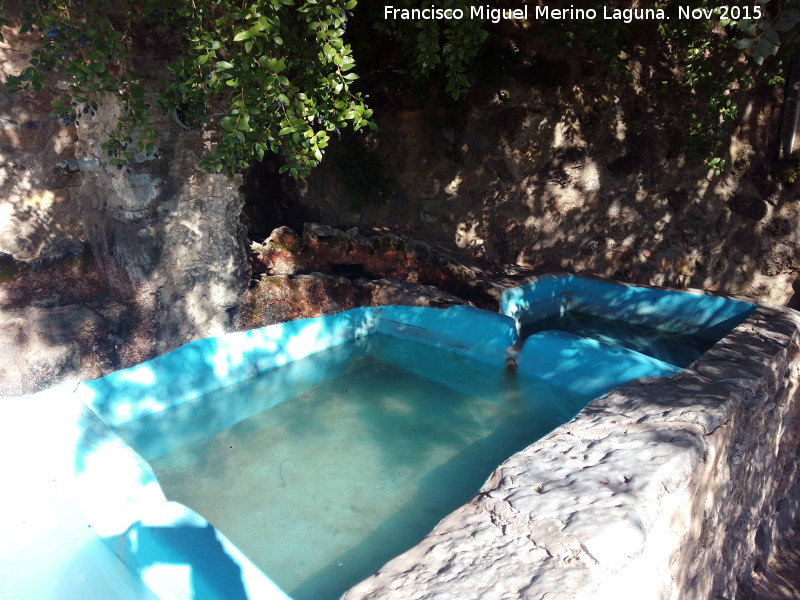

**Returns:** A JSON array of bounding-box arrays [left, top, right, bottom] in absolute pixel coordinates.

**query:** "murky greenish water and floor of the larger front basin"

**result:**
[[150, 334, 589, 600]]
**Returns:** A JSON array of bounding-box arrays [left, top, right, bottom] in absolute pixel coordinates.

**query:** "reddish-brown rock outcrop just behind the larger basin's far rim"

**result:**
[[239, 223, 484, 329]]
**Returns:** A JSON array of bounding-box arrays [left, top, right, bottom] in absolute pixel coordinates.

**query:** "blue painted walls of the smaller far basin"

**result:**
[[500, 275, 754, 396]]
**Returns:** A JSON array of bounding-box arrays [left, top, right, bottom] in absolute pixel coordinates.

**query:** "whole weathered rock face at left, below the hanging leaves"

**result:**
[[0, 11, 249, 394]]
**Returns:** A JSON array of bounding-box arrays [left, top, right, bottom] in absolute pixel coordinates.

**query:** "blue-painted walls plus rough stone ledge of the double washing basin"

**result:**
[[28, 277, 800, 600]]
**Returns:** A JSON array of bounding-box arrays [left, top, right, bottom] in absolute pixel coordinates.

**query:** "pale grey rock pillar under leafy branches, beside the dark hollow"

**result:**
[[70, 98, 249, 353]]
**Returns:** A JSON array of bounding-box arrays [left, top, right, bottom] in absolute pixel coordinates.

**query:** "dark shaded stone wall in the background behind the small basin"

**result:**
[[298, 40, 800, 304]]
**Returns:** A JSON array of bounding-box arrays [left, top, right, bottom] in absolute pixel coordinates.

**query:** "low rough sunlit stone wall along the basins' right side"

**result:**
[[345, 305, 800, 600]]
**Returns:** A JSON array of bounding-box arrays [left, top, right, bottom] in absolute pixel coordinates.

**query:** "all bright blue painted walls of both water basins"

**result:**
[[75, 276, 751, 600]]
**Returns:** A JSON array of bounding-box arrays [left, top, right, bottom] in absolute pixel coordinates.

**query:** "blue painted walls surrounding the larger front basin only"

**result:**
[[70, 306, 517, 600]]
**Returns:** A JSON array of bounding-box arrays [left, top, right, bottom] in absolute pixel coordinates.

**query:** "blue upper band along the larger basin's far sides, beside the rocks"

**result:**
[[76, 306, 517, 427]]
